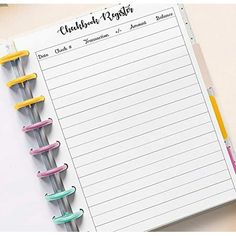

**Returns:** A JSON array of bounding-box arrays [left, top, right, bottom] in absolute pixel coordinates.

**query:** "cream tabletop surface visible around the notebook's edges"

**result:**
[[0, 4, 236, 231]]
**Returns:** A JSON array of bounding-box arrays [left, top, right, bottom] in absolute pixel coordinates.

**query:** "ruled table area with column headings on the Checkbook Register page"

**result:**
[[14, 6, 235, 231]]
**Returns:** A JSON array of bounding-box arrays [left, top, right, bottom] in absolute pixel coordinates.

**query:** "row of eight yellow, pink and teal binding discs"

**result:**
[[0, 50, 84, 230]]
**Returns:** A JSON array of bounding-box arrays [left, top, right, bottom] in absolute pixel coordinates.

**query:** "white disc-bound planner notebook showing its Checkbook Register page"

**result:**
[[0, 4, 236, 231]]
